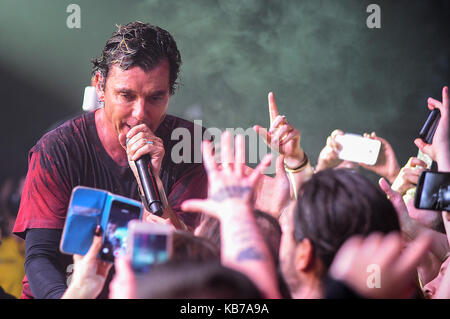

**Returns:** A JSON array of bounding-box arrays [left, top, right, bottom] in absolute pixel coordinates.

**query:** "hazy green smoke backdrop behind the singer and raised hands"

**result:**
[[0, 0, 450, 178]]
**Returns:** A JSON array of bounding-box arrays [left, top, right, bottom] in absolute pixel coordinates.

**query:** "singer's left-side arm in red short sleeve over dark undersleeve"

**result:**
[[13, 140, 70, 298]]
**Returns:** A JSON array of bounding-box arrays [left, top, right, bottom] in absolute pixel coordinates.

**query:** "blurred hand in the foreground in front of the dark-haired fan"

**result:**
[[330, 233, 431, 298]]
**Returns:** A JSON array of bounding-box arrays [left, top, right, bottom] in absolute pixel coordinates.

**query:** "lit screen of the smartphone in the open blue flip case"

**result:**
[[100, 200, 140, 262]]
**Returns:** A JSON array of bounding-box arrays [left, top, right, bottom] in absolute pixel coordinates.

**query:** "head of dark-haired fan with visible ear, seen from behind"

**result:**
[[280, 169, 400, 298]]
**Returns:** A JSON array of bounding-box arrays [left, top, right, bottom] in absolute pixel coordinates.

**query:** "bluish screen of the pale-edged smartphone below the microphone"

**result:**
[[132, 232, 169, 273]]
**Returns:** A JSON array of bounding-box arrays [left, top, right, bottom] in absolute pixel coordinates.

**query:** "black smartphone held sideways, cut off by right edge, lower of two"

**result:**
[[414, 171, 450, 211]]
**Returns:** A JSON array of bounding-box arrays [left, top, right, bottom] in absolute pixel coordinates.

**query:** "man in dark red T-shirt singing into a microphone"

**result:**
[[14, 22, 207, 298]]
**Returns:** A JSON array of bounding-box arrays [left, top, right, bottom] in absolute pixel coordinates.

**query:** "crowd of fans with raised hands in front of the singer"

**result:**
[[0, 87, 450, 299]]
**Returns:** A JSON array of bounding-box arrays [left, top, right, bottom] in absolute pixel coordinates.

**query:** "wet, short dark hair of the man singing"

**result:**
[[92, 21, 181, 94]]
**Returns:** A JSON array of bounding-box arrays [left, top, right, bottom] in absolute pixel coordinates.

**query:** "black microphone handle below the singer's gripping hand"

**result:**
[[134, 154, 163, 217]]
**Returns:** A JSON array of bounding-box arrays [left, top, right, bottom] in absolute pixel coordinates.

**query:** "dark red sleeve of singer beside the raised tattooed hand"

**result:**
[[167, 164, 208, 231]]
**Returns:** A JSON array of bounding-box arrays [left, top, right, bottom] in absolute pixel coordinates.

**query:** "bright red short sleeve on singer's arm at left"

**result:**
[[13, 145, 71, 238]]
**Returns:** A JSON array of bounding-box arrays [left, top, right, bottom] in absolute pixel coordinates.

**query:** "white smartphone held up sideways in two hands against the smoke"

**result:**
[[336, 134, 381, 165]]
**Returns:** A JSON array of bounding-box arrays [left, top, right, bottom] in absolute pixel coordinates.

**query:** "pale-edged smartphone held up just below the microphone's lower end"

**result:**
[[127, 221, 173, 273]]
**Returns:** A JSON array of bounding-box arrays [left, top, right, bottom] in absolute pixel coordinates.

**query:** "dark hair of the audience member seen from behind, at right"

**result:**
[[294, 169, 400, 268]]
